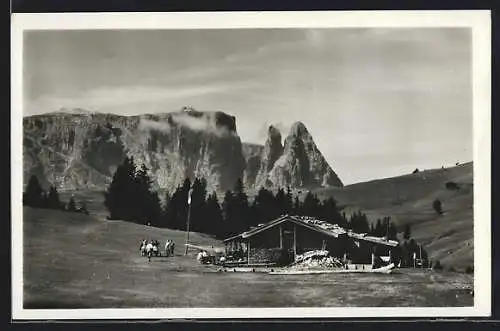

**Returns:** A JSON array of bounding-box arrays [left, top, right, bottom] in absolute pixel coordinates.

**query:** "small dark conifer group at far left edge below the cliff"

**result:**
[[23, 175, 88, 215]]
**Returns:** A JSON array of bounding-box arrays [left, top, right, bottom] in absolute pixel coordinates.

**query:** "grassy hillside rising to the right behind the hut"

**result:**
[[315, 163, 474, 269]]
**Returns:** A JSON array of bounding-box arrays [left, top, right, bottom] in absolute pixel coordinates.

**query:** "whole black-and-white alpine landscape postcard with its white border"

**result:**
[[9, 13, 490, 318]]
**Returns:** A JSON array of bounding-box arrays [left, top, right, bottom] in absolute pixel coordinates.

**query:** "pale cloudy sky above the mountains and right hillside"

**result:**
[[23, 28, 473, 184]]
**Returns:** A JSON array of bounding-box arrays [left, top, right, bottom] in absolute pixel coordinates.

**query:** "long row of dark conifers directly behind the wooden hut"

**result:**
[[104, 157, 406, 239]]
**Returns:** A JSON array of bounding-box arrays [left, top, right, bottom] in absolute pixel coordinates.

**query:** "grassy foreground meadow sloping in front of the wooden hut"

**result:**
[[23, 207, 473, 308]]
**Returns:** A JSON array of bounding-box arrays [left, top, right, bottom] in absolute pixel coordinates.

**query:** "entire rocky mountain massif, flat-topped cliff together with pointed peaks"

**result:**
[[23, 110, 342, 192]]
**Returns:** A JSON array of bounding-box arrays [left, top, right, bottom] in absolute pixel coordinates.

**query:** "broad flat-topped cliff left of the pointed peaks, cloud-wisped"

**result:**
[[23, 110, 246, 190]]
